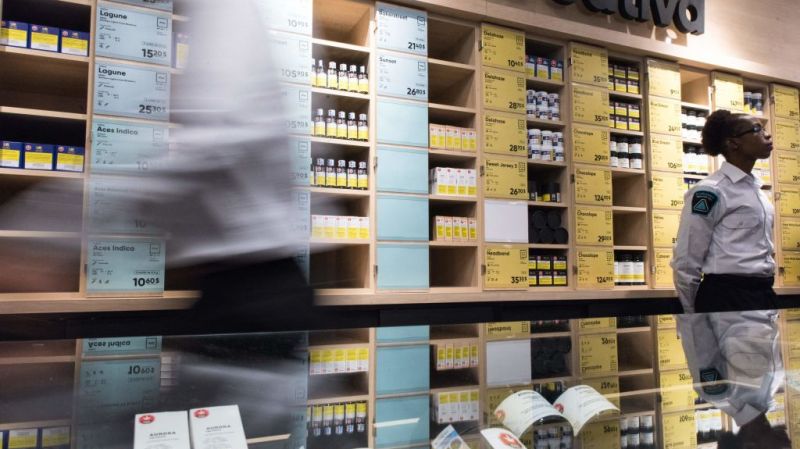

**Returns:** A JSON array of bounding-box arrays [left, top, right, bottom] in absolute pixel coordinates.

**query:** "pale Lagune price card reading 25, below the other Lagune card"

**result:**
[[94, 64, 170, 121]]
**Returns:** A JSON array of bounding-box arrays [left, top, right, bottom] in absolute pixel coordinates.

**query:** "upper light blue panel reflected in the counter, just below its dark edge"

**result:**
[[375, 344, 430, 395]]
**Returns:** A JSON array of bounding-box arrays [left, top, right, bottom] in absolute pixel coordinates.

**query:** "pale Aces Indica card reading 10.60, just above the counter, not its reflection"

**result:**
[[86, 239, 165, 293]]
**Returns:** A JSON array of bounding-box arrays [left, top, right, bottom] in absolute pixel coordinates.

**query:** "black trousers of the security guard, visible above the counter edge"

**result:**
[[695, 274, 778, 313]]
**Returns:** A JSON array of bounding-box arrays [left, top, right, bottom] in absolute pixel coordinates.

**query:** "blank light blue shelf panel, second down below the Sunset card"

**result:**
[[377, 147, 428, 194]]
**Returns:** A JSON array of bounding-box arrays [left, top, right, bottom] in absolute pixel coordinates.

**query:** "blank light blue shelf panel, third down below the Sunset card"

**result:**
[[377, 195, 429, 242]]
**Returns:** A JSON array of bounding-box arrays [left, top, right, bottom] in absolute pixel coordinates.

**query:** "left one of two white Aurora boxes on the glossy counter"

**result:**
[[133, 411, 191, 449]]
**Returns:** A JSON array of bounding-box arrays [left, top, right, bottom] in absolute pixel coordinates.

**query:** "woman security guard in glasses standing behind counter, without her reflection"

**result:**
[[672, 110, 775, 313]]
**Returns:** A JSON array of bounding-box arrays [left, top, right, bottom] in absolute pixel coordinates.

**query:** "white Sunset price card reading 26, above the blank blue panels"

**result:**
[[378, 53, 428, 101]]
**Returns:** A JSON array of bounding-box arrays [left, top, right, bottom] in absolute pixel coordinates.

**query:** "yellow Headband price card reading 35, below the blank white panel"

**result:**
[[485, 245, 528, 290]]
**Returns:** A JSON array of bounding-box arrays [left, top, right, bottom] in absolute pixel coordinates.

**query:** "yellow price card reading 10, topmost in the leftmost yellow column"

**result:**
[[481, 23, 525, 72]]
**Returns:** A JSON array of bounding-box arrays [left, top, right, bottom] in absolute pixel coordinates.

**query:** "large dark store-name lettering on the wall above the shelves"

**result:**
[[553, 0, 706, 34]]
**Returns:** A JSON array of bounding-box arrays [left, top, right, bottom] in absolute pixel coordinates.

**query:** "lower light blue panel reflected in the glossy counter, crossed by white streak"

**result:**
[[375, 394, 430, 448]]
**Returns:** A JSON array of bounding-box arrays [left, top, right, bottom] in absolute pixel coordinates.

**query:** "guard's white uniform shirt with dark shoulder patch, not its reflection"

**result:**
[[671, 162, 775, 313]]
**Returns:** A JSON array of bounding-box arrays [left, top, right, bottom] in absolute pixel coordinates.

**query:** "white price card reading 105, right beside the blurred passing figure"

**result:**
[[269, 31, 314, 86]]
